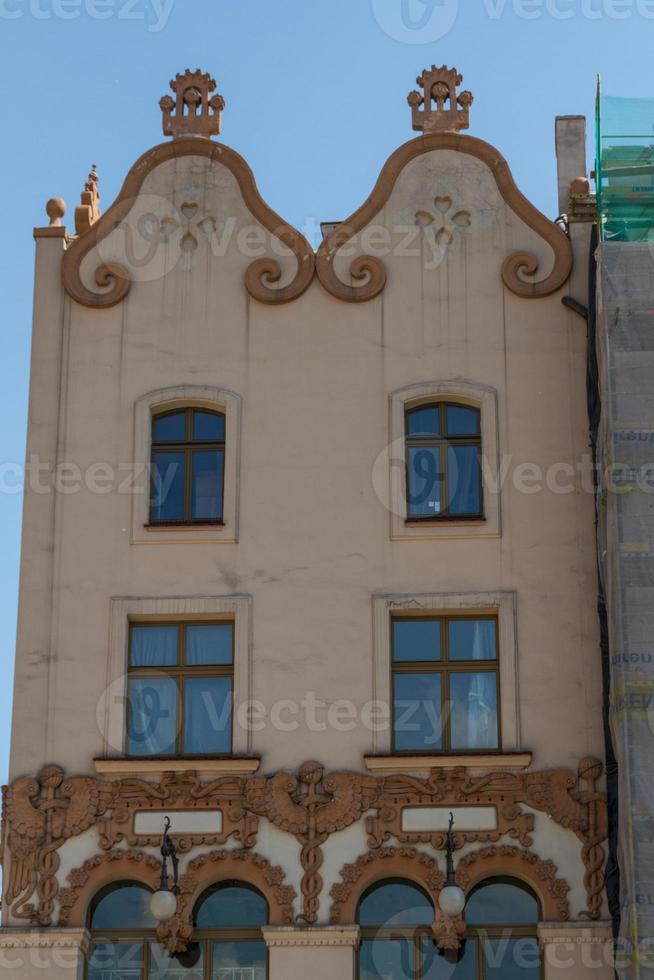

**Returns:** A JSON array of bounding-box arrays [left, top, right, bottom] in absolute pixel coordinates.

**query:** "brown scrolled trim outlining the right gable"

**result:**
[[316, 133, 572, 303]]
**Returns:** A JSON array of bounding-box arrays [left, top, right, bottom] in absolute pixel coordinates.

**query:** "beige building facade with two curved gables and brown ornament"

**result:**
[[0, 67, 613, 980]]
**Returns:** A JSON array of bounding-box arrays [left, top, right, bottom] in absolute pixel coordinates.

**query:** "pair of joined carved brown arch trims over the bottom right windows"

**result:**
[[330, 847, 570, 925]]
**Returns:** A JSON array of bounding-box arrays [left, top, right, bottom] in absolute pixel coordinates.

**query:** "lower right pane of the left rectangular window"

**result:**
[[184, 677, 232, 755]]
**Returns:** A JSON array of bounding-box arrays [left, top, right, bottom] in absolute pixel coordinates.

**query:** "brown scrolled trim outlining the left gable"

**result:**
[[62, 138, 315, 309]]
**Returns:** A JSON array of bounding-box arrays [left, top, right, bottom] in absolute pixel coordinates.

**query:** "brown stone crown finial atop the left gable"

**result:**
[[159, 68, 225, 139]]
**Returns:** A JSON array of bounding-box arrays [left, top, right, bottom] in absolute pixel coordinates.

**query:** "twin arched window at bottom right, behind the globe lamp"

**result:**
[[358, 878, 542, 980]]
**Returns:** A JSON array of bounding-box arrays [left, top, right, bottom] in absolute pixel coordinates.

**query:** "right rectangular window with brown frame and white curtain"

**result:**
[[391, 616, 500, 752]]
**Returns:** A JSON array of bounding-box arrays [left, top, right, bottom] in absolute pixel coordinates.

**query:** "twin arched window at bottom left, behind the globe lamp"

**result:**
[[86, 881, 268, 980]]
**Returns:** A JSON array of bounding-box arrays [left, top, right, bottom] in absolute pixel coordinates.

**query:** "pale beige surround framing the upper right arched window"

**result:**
[[390, 380, 502, 541]]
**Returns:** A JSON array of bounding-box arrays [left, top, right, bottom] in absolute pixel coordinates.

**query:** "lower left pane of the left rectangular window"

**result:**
[[127, 677, 177, 755]]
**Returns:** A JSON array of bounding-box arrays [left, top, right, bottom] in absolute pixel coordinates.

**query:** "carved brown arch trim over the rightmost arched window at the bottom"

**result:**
[[456, 847, 570, 922]]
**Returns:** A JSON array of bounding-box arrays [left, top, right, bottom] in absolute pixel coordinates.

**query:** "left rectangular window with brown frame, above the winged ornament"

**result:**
[[127, 622, 234, 756]]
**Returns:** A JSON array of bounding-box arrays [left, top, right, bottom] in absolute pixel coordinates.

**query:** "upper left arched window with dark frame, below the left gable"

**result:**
[[150, 408, 225, 525]]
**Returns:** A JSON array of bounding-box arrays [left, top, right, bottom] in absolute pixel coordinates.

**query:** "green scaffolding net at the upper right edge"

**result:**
[[596, 84, 654, 242]]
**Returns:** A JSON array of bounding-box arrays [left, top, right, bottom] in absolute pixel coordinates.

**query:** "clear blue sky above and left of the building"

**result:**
[[0, 0, 654, 779]]
